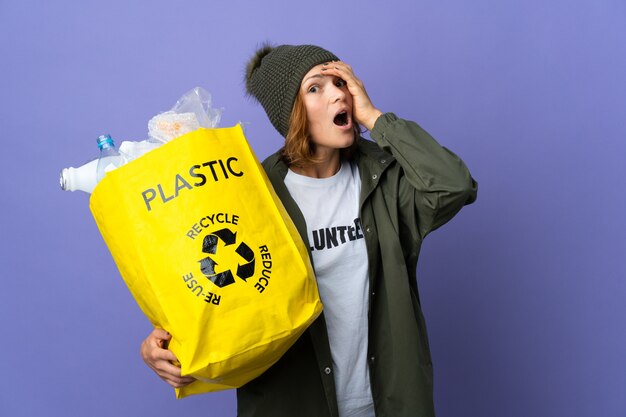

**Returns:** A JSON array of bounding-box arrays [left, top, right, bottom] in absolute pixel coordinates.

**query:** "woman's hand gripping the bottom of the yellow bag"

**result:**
[[141, 329, 196, 388]]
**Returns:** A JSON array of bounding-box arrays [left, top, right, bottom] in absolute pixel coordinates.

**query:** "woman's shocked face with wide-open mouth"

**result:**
[[300, 64, 354, 155]]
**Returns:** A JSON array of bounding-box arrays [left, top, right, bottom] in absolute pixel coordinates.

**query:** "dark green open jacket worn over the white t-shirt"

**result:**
[[237, 113, 477, 417]]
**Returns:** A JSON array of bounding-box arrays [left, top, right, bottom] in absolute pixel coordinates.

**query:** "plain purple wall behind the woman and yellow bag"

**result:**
[[0, 0, 626, 417]]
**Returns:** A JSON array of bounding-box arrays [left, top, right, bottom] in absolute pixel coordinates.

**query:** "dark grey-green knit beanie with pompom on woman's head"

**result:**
[[246, 45, 339, 137]]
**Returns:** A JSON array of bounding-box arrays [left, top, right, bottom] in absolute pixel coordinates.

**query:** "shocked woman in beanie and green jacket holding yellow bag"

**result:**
[[141, 45, 477, 417]]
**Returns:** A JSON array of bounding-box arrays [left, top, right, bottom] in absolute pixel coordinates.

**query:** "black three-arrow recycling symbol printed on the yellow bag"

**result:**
[[198, 228, 254, 288]]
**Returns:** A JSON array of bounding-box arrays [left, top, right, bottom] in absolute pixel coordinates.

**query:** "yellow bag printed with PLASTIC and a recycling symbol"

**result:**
[[90, 125, 322, 398]]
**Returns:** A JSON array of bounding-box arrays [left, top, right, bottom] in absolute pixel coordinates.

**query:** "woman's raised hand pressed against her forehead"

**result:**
[[322, 61, 382, 130]]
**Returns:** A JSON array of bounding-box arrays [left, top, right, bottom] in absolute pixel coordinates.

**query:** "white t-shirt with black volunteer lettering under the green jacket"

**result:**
[[285, 161, 374, 417]]
